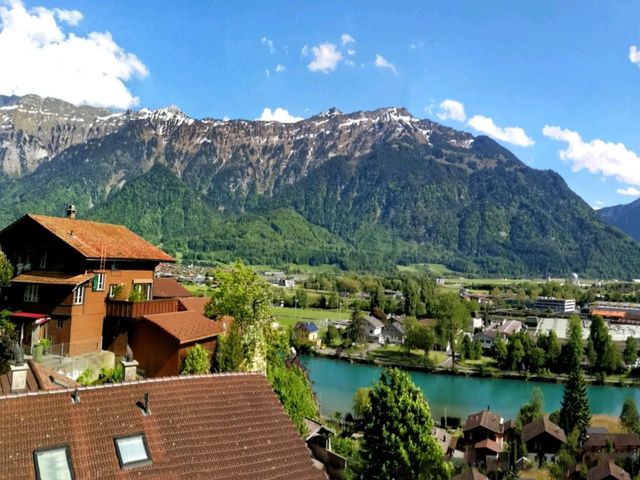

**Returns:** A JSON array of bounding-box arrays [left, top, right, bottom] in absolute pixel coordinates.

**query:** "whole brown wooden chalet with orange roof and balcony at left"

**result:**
[[0, 209, 177, 355]]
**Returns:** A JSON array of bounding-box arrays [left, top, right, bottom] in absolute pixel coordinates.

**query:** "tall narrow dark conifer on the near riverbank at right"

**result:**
[[560, 366, 591, 444]]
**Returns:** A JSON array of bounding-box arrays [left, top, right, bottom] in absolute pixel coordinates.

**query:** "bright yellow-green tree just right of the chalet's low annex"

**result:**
[[205, 262, 273, 371]]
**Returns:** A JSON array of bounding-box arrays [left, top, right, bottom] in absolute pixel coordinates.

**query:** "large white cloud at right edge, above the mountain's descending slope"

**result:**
[[542, 125, 640, 185]]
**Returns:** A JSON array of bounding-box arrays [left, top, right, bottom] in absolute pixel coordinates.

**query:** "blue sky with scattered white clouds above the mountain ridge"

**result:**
[[0, 0, 640, 206]]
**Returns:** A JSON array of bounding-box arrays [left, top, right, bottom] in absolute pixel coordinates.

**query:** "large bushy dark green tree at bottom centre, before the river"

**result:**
[[362, 369, 451, 480]]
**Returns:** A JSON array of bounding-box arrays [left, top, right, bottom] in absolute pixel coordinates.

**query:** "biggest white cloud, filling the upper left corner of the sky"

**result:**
[[0, 0, 148, 108]]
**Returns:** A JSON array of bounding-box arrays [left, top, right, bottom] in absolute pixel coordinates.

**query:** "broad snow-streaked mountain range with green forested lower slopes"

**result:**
[[0, 95, 640, 278]]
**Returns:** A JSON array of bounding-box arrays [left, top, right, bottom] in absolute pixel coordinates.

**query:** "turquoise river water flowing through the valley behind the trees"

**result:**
[[302, 356, 640, 419]]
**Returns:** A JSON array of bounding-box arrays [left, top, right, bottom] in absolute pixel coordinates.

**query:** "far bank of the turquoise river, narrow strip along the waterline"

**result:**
[[309, 348, 640, 387]]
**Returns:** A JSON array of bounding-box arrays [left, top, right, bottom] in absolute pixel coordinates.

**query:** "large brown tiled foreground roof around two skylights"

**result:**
[[0, 374, 326, 480]]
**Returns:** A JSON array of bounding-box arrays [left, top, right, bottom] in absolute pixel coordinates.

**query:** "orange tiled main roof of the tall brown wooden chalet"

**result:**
[[27, 215, 175, 262]]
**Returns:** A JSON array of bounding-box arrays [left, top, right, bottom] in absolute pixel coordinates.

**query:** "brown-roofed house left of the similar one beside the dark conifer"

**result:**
[[462, 410, 510, 464]]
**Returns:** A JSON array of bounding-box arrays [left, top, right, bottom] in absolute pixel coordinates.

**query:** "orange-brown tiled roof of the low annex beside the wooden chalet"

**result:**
[[142, 310, 224, 343]]
